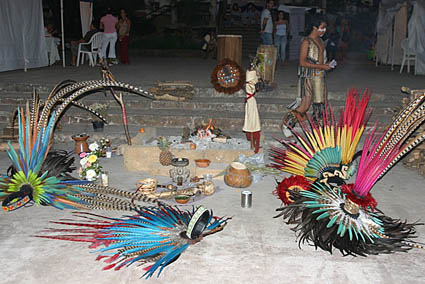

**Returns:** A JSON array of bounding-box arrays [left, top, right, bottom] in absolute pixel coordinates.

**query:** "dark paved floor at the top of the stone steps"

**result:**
[[0, 51, 424, 94]]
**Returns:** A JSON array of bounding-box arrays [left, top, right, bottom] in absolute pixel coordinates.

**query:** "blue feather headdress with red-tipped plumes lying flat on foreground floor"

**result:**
[[37, 206, 229, 278]]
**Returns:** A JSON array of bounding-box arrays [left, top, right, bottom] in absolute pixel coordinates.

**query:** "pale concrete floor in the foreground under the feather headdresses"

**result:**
[[0, 145, 425, 283]]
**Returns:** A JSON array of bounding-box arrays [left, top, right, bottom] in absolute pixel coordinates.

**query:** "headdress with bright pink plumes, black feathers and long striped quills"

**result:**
[[276, 89, 425, 256]]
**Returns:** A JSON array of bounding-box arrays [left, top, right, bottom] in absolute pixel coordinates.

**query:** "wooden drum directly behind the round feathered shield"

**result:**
[[217, 35, 242, 66]]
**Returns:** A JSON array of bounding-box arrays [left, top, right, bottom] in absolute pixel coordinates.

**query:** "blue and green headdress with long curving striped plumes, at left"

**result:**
[[0, 80, 158, 211]]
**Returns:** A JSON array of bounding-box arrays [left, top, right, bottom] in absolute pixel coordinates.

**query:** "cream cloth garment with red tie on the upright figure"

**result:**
[[242, 70, 261, 132]]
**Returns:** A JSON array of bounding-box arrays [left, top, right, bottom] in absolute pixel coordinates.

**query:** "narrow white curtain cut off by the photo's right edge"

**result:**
[[408, 1, 425, 75]]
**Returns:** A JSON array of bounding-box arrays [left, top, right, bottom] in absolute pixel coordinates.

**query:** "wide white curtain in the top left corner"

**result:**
[[0, 0, 48, 72]]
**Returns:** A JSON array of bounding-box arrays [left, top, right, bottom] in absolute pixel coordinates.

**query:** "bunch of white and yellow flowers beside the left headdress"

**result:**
[[80, 142, 102, 181]]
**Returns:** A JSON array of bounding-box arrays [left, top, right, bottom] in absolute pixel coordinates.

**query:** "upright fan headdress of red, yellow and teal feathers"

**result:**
[[270, 89, 371, 181]]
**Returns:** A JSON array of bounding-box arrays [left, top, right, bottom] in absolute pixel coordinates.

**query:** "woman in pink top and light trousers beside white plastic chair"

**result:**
[[100, 8, 118, 64]]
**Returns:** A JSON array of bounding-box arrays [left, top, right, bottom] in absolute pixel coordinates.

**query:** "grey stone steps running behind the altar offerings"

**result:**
[[0, 81, 398, 144]]
